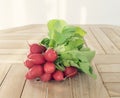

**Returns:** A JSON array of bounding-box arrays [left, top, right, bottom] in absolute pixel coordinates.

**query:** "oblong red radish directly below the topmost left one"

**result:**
[[29, 54, 45, 65]]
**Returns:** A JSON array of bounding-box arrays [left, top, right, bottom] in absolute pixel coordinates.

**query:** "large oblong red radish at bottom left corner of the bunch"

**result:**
[[26, 65, 43, 79]]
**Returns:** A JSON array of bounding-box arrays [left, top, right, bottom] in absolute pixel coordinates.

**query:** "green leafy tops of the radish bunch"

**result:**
[[40, 19, 96, 78]]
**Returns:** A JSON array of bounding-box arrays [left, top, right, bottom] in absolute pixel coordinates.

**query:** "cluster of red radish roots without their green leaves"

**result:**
[[24, 43, 78, 82]]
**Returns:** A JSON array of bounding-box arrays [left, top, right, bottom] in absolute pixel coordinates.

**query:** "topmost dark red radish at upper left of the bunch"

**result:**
[[29, 43, 46, 53]]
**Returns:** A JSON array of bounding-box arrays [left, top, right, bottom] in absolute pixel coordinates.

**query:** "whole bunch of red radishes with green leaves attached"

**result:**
[[24, 19, 96, 82]]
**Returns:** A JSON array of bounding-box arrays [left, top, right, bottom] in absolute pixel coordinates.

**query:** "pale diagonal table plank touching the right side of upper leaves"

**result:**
[[81, 26, 105, 54]]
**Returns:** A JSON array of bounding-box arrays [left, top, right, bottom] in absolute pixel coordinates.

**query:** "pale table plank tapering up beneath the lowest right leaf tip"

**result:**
[[89, 64, 110, 98]]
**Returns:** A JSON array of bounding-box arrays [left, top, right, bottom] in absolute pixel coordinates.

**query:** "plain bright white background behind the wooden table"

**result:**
[[0, 0, 120, 29]]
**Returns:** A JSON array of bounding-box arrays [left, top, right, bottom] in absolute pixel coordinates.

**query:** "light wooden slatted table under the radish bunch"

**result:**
[[0, 25, 120, 98]]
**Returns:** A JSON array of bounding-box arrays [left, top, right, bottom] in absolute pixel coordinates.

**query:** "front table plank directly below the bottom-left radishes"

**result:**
[[21, 80, 48, 98]]
